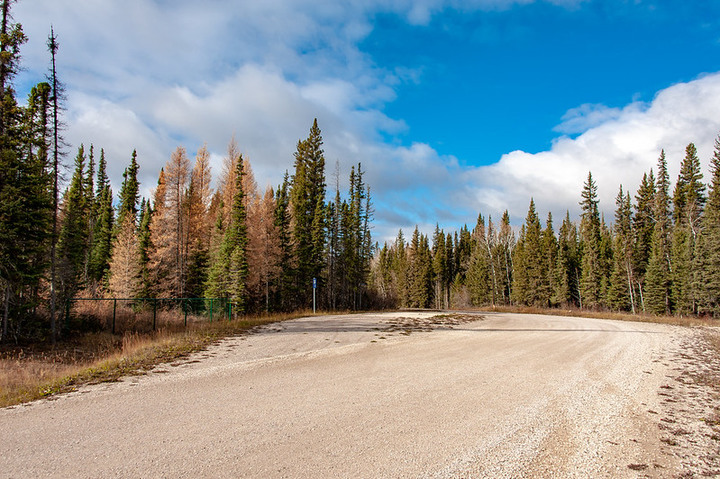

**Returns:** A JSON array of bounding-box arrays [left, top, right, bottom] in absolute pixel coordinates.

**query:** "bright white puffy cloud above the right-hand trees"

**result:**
[[464, 74, 720, 225]]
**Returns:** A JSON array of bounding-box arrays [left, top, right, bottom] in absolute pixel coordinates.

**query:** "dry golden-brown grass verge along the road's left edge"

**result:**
[[0, 312, 312, 407]]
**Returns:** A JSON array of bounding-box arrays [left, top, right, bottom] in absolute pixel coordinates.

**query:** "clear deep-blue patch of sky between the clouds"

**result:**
[[368, 1, 720, 161]]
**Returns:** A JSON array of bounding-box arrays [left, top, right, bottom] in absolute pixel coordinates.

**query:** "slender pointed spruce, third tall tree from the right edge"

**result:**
[[645, 151, 672, 314]]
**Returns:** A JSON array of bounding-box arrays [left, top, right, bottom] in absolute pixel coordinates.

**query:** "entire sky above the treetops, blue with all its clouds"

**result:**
[[14, 0, 720, 240]]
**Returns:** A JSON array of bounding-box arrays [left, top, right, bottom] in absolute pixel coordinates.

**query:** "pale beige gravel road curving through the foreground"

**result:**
[[0, 312, 704, 478]]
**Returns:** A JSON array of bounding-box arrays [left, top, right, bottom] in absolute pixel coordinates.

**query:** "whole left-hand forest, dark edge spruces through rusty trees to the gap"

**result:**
[[0, 0, 372, 341]]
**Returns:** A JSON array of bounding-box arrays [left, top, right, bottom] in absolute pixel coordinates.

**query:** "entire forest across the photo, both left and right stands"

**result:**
[[0, 0, 720, 342]]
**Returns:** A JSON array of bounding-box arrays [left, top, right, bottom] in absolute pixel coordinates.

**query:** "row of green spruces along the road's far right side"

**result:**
[[371, 141, 720, 317]]
